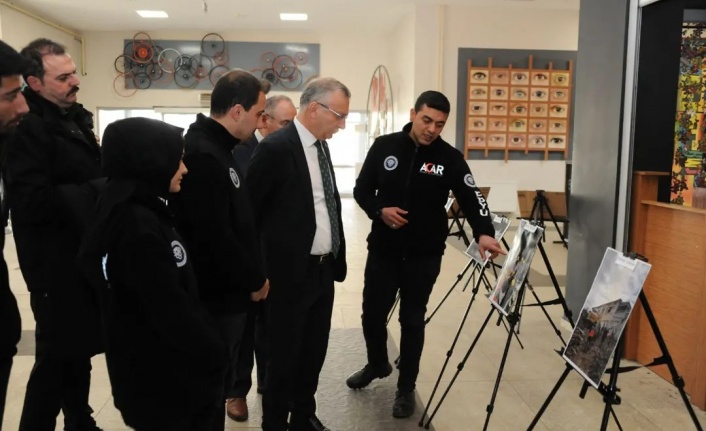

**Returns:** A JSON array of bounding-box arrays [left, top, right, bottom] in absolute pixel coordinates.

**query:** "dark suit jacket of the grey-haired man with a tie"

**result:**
[[248, 122, 347, 299]]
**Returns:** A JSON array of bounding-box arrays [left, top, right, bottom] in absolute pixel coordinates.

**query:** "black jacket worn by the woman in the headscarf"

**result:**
[[99, 197, 225, 419]]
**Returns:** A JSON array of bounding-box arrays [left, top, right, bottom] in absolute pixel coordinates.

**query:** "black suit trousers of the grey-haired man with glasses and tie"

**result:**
[[262, 258, 334, 431]]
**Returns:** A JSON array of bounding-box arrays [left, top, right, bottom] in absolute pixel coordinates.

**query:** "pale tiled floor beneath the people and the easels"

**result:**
[[3, 199, 706, 431]]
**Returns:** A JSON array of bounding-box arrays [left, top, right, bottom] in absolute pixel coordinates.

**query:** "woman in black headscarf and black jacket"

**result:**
[[81, 118, 226, 431]]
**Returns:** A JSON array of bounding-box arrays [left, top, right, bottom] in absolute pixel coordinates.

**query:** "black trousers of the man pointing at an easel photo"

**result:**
[[363, 252, 441, 391]]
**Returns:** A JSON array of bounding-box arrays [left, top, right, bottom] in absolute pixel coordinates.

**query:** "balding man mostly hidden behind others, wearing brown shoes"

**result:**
[[226, 95, 297, 422]]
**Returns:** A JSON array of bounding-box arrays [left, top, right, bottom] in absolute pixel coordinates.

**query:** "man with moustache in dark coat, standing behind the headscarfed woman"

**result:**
[[4, 39, 101, 431]]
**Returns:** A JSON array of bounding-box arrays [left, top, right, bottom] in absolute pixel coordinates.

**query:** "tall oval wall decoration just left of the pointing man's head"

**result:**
[[366, 65, 395, 148]]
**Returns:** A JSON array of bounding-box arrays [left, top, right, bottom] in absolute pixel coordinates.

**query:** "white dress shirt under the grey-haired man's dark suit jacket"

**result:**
[[294, 117, 336, 256]]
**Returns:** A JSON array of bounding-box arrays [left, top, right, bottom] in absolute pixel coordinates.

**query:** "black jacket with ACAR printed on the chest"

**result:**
[[353, 123, 495, 257]]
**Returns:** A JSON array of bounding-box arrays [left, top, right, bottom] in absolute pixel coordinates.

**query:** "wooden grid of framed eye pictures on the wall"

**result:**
[[465, 56, 573, 161]]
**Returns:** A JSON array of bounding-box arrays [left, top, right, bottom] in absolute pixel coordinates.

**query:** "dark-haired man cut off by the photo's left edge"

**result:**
[[0, 40, 29, 427]]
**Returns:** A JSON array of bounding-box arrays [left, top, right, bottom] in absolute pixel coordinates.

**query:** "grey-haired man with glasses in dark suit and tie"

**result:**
[[247, 78, 350, 431]]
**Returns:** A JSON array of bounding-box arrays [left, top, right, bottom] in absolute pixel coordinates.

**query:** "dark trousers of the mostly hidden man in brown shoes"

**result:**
[[226, 301, 268, 398]]
